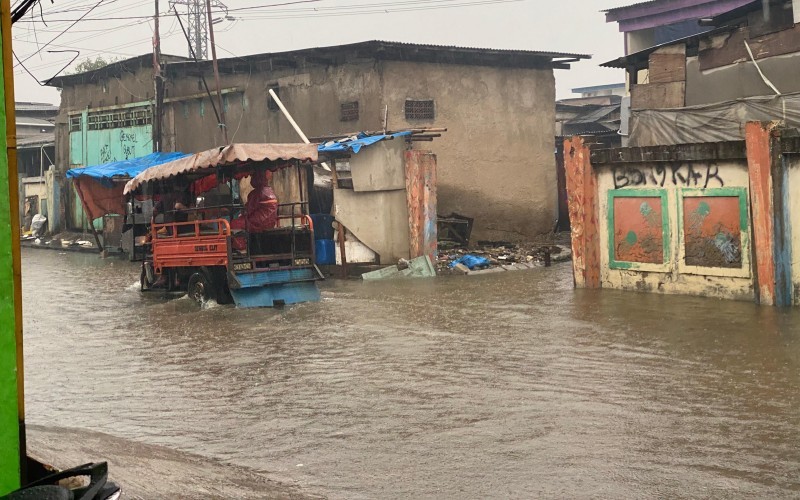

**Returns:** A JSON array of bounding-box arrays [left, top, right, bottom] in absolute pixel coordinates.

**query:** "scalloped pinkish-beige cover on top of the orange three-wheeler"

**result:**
[[124, 144, 319, 194]]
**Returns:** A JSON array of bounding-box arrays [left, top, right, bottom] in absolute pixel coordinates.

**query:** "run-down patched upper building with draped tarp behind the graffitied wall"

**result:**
[[602, 0, 800, 146]]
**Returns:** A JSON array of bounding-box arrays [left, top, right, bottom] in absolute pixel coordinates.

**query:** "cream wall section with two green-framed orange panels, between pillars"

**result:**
[[597, 160, 754, 300]]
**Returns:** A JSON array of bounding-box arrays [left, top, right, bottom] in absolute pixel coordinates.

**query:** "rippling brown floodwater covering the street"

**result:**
[[18, 249, 800, 498]]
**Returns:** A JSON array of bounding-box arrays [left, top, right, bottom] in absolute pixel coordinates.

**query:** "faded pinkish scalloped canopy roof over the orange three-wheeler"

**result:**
[[124, 143, 319, 195]]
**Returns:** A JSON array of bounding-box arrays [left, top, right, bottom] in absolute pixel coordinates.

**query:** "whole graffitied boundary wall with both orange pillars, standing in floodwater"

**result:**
[[565, 122, 800, 305]]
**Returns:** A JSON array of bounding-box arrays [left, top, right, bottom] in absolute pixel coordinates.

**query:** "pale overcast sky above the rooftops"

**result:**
[[7, 0, 634, 104]]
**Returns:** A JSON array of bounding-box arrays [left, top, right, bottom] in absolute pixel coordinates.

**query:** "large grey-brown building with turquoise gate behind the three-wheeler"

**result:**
[[50, 41, 588, 240]]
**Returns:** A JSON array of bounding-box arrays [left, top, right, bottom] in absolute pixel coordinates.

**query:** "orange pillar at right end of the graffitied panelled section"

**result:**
[[745, 122, 781, 305]]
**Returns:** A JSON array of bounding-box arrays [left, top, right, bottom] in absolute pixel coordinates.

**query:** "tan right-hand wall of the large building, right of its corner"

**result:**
[[382, 62, 557, 240]]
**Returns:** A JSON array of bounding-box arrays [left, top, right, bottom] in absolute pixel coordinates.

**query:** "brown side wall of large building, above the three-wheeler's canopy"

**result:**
[[165, 61, 382, 152]]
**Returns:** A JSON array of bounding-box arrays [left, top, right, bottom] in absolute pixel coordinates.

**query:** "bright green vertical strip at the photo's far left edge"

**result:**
[[0, 20, 20, 495]]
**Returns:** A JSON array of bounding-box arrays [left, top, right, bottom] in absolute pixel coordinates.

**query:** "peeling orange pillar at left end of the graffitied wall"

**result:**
[[564, 136, 600, 288]]
